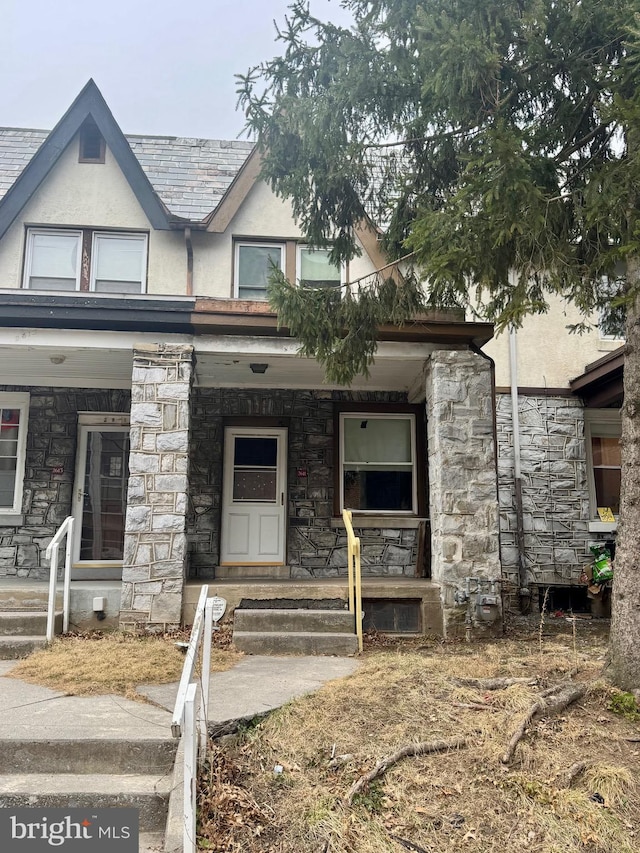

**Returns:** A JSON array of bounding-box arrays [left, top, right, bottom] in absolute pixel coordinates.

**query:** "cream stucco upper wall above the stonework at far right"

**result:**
[[483, 297, 621, 388]]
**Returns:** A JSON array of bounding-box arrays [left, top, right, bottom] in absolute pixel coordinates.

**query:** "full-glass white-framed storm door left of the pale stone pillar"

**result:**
[[73, 424, 129, 578]]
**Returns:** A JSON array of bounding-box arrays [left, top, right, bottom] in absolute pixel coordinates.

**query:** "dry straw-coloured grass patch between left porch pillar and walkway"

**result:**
[[8, 632, 242, 701]]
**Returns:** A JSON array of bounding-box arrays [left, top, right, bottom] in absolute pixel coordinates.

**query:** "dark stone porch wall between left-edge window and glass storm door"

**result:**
[[0, 385, 131, 580]]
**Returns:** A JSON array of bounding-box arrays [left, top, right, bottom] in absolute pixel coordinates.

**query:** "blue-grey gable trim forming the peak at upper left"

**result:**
[[0, 80, 181, 237]]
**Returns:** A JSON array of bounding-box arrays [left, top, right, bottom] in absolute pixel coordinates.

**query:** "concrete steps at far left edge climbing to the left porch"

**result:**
[[0, 584, 62, 660]]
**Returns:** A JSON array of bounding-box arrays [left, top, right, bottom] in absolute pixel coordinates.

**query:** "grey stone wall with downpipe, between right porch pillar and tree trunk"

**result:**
[[497, 394, 596, 589]]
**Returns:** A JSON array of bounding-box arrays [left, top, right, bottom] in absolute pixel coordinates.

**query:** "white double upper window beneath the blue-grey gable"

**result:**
[[24, 228, 147, 293]]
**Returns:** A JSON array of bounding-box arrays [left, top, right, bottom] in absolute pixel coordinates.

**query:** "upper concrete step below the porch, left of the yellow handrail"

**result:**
[[233, 608, 355, 634]]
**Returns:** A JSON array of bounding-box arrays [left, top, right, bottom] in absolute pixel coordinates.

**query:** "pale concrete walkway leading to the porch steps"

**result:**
[[0, 656, 359, 853]]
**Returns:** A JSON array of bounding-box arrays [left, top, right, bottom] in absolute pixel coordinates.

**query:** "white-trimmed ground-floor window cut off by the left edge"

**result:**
[[0, 393, 29, 515]]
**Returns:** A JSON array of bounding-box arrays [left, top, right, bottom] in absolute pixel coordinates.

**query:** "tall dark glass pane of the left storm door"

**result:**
[[80, 430, 129, 561]]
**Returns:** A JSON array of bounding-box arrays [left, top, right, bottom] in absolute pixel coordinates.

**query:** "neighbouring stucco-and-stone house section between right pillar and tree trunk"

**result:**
[[484, 300, 624, 608]]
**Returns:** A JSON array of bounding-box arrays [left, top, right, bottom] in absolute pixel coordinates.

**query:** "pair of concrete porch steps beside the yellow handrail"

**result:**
[[233, 601, 358, 655]]
